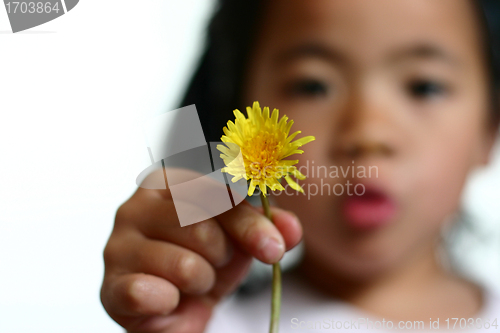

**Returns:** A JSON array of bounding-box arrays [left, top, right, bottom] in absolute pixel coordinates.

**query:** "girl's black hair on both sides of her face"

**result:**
[[180, 0, 500, 137]]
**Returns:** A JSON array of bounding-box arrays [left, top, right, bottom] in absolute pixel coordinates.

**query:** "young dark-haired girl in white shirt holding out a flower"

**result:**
[[101, 0, 500, 333]]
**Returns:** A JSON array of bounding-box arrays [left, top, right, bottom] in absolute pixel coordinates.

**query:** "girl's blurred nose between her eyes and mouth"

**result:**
[[334, 87, 396, 159]]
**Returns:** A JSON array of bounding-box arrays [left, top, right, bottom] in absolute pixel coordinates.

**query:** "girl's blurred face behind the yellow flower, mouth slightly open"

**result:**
[[246, 0, 493, 278]]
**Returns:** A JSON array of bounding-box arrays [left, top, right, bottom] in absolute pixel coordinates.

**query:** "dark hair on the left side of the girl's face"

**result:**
[[180, 0, 264, 142]]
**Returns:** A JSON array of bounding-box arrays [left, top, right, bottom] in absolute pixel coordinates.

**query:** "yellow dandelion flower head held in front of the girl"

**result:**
[[217, 102, 315, 196]]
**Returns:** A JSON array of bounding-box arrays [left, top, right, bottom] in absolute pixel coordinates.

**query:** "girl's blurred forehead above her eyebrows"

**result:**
[[259, 0, 480, 66]]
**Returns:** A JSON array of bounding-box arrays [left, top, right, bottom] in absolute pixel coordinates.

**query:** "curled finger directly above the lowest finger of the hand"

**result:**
[[124, 238, 215, 294]]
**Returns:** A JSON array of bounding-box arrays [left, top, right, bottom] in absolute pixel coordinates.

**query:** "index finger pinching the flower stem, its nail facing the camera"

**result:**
[[217, 201, 285, 264]]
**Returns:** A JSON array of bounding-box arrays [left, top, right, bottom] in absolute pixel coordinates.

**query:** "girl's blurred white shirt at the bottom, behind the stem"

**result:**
[[206, 275, 500, 333]]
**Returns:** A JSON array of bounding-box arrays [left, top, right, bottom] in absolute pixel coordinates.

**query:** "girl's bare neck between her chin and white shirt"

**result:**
[[298, 236, 480, 319]]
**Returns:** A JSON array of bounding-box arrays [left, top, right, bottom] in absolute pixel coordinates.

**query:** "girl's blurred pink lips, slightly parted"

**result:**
[[341, 186, 397, 230]]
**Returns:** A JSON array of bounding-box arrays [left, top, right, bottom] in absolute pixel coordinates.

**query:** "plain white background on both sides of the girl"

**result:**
[[0, 0, 500, 333]]
